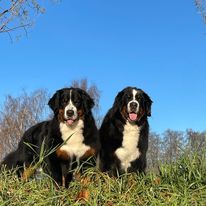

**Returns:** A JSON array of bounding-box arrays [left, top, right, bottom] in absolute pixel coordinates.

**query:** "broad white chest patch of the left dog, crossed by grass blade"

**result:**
[[60, 120, 90, 160]]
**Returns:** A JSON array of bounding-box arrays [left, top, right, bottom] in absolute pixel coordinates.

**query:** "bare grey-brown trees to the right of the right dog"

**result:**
[[147, 129, 206, 170]]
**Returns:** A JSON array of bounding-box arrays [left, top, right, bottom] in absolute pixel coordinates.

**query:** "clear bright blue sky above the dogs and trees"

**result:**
[[0, 0, 206, 133]]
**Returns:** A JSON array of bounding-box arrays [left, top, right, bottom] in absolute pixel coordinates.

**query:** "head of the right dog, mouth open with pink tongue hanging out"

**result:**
[[113, 87, 152, 122]]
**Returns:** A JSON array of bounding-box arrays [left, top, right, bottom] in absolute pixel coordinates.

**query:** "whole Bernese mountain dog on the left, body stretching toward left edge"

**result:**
[[2, 87, 99, 187]]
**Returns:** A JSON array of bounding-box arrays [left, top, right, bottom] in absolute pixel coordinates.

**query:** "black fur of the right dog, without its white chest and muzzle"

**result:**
[[99, 87, 152, 176]]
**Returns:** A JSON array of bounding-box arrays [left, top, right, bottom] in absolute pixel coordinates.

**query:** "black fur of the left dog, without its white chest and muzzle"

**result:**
[[1, 88, 99, 187]]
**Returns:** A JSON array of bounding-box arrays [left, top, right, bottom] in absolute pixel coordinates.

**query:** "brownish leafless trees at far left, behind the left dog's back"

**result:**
[[0, 89, 48, 159]]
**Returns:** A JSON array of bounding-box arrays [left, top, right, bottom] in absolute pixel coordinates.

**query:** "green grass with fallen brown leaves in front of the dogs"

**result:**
[[0, 152, 206, 206]]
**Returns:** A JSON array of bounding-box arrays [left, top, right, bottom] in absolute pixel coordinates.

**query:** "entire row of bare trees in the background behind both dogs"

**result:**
[[0, 79, 206, 170]]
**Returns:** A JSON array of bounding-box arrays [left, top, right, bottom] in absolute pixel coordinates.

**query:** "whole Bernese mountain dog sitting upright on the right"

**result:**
[[99, 87, 152, 176]]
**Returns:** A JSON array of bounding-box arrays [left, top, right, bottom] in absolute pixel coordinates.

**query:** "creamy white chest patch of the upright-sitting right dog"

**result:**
[[115, 121, 140, 172]]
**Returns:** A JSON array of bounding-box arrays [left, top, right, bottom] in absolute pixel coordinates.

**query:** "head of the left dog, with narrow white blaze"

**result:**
[[48, 87, 94, 126]]
